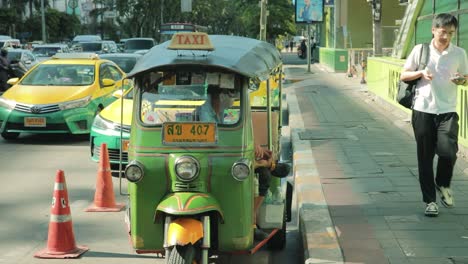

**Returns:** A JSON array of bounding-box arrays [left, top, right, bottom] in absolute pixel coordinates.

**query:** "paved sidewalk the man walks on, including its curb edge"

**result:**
[[284, 64, 468, 264]]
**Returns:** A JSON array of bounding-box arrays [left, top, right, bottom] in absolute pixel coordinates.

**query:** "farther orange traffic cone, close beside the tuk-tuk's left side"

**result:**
[[85, 143, 125, 212]]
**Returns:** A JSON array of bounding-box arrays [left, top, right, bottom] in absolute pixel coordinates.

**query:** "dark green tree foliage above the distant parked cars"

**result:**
[[0, 0, 296, 41]]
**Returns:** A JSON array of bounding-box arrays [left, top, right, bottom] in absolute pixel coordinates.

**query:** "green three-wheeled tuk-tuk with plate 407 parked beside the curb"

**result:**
[[120, 32, 291, 263]]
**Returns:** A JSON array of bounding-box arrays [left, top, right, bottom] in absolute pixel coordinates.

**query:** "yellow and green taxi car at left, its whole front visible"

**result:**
[[0, 53, 129, 140]]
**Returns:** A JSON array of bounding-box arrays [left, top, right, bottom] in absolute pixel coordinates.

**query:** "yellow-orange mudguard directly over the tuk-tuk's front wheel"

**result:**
[[167, 218, 203, 246]]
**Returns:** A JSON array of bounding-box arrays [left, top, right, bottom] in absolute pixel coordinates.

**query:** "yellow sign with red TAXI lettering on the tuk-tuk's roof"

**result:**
[[167, 32, 214, 50]]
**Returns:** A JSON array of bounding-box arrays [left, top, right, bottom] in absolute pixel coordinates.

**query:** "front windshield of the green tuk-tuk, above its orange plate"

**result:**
[[139, 72, 241, 126]]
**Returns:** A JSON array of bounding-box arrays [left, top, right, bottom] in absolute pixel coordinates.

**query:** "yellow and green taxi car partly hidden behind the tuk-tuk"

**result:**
[[90, 85, 133, 171]]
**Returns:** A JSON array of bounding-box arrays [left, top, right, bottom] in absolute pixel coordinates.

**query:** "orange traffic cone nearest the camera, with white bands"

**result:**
[[34, 170, 89, 258]]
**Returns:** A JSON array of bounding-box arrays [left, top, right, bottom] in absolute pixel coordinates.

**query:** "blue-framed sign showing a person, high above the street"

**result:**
[[295, 0, 324, 23]]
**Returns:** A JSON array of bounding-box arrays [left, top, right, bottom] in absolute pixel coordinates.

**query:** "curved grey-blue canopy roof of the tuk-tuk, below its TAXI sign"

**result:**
[[127, 35, 282, 81]]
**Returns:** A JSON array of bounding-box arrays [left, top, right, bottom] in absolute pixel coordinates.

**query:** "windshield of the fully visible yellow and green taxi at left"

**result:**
[[21, 64, 94, 86]]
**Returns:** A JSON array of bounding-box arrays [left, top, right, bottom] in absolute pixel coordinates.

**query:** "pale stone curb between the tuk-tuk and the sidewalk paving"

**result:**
[[286, 85, 344, 264]]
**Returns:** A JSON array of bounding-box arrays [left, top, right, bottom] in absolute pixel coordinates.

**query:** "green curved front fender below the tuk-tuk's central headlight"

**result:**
[[154, 192, 224, 223]]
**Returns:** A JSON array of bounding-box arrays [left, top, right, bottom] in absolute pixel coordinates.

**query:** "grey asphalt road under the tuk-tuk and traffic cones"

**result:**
[[0, 89, 303, 264]]
